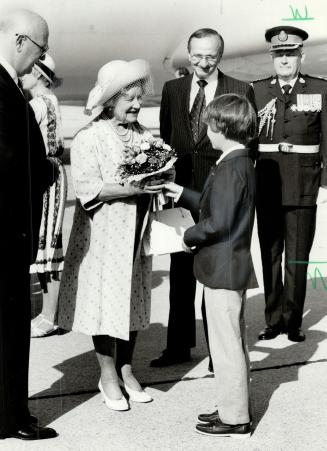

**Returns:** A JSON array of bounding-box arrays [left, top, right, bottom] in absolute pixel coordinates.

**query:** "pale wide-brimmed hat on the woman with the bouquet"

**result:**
[[85, 59, 152, 114]]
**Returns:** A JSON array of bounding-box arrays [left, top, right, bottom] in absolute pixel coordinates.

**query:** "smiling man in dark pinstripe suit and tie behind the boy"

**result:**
[[151, 28, 253, 370]]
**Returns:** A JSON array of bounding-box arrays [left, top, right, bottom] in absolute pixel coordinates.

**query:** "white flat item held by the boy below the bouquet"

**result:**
[[143, 199, 194, 255]]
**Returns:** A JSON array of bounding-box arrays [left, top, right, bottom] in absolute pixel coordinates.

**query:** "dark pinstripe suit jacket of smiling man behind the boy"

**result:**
[[160, 71, 254, 191]]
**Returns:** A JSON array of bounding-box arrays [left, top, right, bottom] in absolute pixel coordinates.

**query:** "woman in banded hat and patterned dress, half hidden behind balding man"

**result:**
[[21, 54, 67, 337]]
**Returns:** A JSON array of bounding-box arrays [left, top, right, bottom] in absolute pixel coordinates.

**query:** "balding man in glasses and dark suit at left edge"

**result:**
[[0, 10, 57, 440]]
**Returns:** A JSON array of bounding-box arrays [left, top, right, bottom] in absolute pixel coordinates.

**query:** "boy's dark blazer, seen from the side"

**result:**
[[180, 149, 257, 290]]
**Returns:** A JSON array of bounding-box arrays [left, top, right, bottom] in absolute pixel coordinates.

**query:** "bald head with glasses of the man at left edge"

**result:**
[[0, 9, 49, 76]]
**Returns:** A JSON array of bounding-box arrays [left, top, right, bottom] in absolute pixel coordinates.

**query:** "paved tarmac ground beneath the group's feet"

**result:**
[[0, 166, 327, 451]]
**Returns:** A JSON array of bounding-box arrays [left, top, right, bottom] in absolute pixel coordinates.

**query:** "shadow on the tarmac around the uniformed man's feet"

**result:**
[[247, 280, 327, 428]]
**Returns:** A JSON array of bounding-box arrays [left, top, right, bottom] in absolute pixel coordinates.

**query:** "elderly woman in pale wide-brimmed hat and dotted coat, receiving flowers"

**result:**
[[59, 60, 163, 410]]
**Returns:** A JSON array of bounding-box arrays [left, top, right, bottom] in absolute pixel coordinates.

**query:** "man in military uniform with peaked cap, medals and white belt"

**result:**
[[253, 26, 327, 342]]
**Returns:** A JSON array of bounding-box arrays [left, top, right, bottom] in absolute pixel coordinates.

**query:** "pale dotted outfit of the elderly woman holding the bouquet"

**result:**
[[59, 120, 152, 340]]
